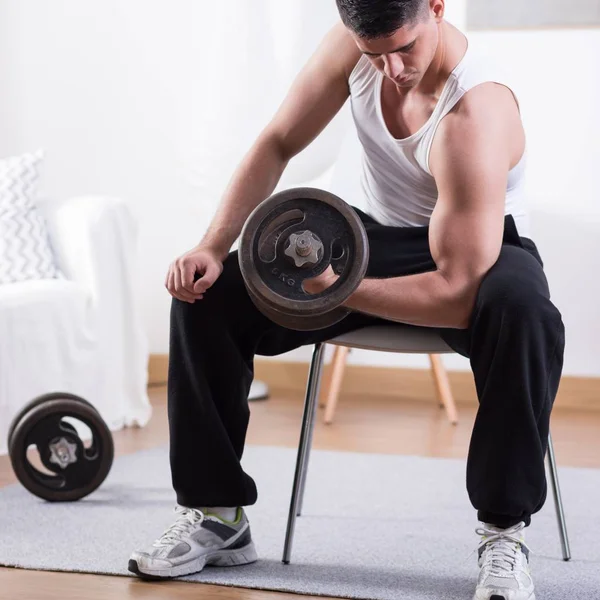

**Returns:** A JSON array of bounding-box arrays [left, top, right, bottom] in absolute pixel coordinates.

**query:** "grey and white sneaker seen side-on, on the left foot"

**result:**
[[129, 506, 257, 579]]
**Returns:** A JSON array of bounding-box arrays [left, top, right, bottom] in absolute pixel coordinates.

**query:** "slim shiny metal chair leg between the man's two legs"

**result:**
[[282, 343, 325, 565]]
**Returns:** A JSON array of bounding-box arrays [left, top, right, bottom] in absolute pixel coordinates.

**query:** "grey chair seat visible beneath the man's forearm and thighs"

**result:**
[[328, 323, 454, 354]]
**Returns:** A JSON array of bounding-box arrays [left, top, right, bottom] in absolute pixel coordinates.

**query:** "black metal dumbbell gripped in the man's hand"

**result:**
[[238, 187, 369, 331]]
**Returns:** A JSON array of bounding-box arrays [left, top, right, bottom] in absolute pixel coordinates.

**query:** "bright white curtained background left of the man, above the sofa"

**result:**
[[0, 0, 356, 353]]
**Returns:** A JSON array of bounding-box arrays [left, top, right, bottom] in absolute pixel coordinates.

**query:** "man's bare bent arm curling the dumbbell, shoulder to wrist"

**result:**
[[332, 84, 522, 329]]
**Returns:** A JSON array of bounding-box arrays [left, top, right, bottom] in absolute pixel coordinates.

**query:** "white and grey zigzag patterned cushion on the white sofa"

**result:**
[[0, 150, 63, 284]]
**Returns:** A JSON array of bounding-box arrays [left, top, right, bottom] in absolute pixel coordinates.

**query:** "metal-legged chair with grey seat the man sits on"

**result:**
[[282, 323, 571, 564]]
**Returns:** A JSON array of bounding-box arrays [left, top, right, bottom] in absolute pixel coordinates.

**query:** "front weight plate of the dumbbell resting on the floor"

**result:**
[[9, 399, 114, 502]]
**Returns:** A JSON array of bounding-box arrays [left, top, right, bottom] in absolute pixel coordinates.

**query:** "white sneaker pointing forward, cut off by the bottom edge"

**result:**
[[473, 522, 535, 600]]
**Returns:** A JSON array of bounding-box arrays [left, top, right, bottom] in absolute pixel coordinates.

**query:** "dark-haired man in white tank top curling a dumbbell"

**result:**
[[130, 0, 564, 600]]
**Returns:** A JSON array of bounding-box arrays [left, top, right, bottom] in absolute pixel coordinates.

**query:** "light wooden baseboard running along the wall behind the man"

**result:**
[[149, 355, 600, 411]]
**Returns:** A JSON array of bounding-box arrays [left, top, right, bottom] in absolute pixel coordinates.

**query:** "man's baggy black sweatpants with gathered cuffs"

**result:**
[[168, 210, 564, 527]]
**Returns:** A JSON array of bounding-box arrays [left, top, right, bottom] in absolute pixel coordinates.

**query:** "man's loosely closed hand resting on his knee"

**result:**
[[165, 245, 223, 304]]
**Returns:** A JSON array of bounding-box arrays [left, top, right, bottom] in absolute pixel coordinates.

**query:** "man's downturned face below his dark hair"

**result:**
[[353, 14, 439, 88]]
